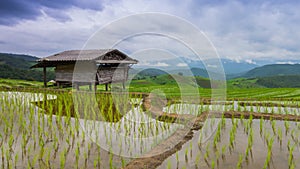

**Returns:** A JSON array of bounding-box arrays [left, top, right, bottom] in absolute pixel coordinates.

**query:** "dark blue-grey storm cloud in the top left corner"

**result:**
[[0, 0, 103, 25]]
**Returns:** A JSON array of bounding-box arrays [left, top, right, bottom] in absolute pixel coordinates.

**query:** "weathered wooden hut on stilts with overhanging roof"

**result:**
[[31, 49, 138, 90]]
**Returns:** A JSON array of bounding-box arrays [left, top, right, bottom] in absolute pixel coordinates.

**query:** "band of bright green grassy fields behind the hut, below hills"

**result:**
[[0, 77, 300, 100]]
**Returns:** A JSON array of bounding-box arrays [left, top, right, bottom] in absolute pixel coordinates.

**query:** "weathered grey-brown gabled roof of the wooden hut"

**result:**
[[31, 49, 138, 68]]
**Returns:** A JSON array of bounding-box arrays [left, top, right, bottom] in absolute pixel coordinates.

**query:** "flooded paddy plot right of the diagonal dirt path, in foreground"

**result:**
[[158, 119, 300, 169]]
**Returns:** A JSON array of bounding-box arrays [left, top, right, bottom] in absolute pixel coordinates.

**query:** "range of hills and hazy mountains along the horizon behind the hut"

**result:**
[[0, 53, 300, 88]]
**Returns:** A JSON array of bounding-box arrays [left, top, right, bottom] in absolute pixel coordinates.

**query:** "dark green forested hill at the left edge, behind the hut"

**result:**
[[0, 53, 55, 81]]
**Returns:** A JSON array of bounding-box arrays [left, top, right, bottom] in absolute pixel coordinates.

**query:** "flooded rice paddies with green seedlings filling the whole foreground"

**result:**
[[0, 92, 300, 168]]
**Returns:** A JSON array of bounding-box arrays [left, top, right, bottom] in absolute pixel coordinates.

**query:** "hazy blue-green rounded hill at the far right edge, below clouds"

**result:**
[[241, 64, 300, 78]]
